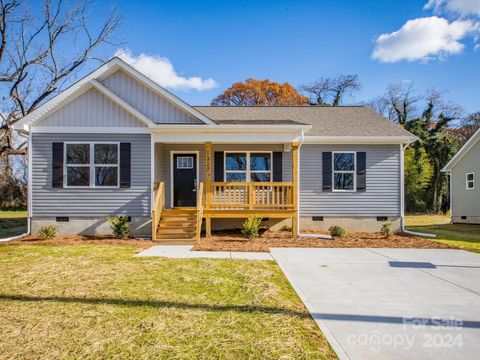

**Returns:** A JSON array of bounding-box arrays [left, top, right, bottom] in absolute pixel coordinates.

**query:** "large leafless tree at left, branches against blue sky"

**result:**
[[0, 0, 120, 161]]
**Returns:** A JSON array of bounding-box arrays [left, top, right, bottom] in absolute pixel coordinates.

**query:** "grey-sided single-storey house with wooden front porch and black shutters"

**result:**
[[15, 58, 416, 239]]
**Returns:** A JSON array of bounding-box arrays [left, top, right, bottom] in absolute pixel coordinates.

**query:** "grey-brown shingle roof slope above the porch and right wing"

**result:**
[[194, 106, 413, 137]]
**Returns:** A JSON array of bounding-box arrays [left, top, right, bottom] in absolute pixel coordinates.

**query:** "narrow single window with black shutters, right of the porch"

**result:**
[[332, 152, 356, 191]]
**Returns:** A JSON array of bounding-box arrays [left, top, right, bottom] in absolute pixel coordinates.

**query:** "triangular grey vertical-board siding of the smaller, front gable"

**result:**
[[35, 89, 145, 127]]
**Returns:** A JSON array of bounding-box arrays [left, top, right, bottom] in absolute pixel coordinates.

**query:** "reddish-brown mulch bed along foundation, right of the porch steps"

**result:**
[[193, 231, 454, 252]]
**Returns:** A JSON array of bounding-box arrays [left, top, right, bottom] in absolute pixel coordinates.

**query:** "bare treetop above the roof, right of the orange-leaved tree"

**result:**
[[300, 75, 362, 106]]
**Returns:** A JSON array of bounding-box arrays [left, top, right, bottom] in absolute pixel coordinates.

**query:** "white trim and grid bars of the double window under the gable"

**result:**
[[63, 141, 120, 189]]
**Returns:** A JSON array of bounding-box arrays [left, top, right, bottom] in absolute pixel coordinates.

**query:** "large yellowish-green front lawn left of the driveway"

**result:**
[[0, 244, 336, 359]]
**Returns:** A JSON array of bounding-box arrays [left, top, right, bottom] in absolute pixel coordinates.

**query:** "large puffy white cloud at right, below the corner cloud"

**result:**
[[372, 16, 478, 63]]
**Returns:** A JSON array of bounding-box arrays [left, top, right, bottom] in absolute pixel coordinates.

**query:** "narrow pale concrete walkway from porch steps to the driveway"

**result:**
[[136, 245, 273, 260]]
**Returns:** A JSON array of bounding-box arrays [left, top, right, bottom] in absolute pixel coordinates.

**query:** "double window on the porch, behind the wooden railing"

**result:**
[[225, 152, 272, 182]]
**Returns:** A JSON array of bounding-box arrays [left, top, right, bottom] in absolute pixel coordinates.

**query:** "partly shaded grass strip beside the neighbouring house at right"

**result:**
[[405, 215, 480, 253]]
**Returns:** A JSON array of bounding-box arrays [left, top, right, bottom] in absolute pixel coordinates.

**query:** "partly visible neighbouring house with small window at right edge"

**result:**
[[442, 129, 480, 224]]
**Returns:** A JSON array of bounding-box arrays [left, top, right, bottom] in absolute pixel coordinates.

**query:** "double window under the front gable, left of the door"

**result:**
[[65, 143, 119, 187]]
